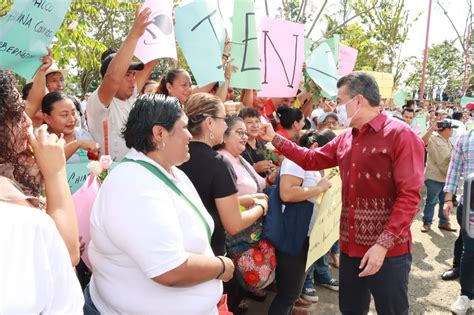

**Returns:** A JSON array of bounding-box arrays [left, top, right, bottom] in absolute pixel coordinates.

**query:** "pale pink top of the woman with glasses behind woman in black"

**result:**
[[219, 149, 266, 196]]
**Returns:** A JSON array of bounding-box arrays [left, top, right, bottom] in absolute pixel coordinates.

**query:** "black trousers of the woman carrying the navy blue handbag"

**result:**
[[268, 238, 309, 315]]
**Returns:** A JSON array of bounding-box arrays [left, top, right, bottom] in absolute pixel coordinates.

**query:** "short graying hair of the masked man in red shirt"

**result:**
[[337, 71, 381, 107]]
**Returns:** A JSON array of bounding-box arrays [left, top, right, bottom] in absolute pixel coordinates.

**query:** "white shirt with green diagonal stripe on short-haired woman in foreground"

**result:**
[[89, 149, 222, 315]]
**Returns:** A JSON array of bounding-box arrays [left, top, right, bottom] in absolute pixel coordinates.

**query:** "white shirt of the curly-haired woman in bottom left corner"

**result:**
[[0, 202, 84, 314]]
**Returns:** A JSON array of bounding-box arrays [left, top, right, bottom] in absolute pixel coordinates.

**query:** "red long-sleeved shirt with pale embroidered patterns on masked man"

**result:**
[[272, 113, 424, 257]]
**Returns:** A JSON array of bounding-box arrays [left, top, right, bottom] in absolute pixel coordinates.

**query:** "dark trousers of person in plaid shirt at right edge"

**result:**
[[457, 208, 474, 300]]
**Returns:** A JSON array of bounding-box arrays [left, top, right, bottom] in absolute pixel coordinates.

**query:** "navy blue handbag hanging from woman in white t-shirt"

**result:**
[[263, 174, 314, 256]]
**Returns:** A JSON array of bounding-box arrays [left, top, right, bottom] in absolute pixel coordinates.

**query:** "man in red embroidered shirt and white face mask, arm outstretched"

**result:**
[[262, 72, 424, 315]]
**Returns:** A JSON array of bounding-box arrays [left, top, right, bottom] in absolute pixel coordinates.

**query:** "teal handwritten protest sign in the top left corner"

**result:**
[[0, 0, 71, 80]]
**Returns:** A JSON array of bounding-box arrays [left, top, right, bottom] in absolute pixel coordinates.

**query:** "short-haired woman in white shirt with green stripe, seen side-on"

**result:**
[[85, 94, 234, 314]]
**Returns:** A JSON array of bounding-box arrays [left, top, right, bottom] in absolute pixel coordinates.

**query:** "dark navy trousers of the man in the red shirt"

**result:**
[[339, 253, 412, 315]]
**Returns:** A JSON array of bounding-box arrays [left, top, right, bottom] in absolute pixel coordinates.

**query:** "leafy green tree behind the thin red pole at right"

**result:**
[[406, 40, 464, 99]]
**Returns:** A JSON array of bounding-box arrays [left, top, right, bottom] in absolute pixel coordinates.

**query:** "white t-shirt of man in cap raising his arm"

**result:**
[[86, 85, 138, 161]]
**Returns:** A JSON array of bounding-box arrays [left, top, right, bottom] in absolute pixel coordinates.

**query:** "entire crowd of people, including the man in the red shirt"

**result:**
[[0, 9, 474, 315]]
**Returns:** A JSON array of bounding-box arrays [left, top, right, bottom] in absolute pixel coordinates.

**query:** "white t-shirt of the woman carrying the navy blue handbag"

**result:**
[[280, 159, 322, 236]]
